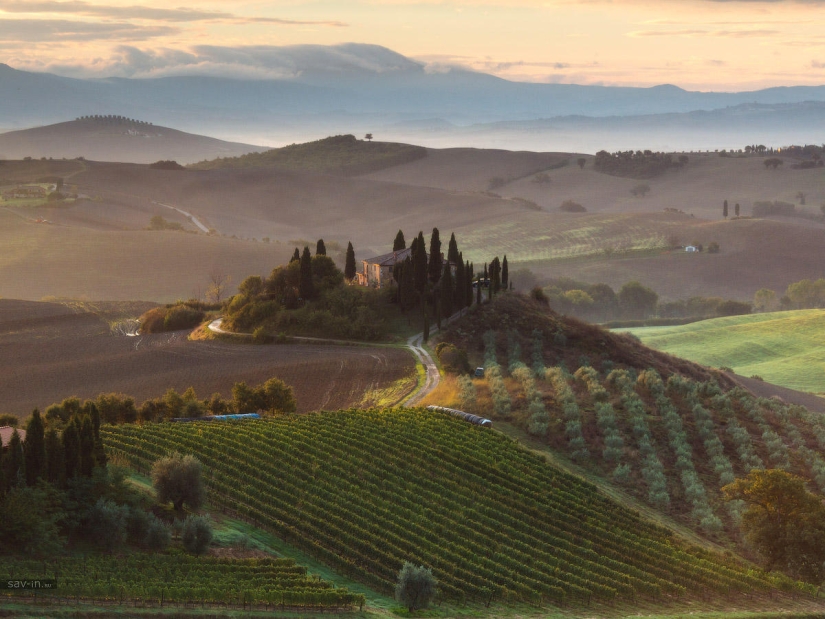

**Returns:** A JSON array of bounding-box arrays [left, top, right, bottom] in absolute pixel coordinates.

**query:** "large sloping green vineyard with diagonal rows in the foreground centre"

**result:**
[[101, 409, 796, 604]]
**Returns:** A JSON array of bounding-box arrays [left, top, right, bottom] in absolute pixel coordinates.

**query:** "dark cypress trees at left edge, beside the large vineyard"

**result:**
[[0, 404, 106, 498]]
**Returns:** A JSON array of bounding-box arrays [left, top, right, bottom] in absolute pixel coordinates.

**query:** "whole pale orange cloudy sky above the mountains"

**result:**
[[0, 0, 825, 90]]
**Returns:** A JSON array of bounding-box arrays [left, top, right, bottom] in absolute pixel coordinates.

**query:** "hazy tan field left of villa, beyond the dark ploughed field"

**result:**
[[0, 208, 294, 302]]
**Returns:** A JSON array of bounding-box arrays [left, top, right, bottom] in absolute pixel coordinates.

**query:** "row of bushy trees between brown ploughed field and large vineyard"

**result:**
[[45, 378, 297, 427]]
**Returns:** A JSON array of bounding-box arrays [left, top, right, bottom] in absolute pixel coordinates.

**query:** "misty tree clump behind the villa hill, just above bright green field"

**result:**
[[543, 278, 748, 322]]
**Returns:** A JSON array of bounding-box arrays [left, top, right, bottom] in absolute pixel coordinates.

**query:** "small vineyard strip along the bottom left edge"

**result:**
[[0, 553, 364, 610]]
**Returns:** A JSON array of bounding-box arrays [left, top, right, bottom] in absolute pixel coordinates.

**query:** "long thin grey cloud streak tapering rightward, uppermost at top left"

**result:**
[[0, 0, 347, 27]]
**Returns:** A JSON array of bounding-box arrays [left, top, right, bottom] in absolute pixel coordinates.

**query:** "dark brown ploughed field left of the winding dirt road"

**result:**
[[0, 300, 415, 416]]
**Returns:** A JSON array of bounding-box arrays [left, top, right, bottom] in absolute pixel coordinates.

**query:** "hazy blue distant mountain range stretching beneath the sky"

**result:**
[[0, 44, 825, 150]]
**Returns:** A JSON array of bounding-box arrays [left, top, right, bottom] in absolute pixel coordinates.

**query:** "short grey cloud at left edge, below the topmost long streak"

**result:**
[[0, 19, 179, 43]]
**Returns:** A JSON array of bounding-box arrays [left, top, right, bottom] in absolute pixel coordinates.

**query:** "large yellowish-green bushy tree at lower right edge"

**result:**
[[722, 469, 825, 584]]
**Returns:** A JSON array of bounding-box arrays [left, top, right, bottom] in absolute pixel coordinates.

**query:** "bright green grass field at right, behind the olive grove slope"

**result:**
[[628, 310, 825, 393]]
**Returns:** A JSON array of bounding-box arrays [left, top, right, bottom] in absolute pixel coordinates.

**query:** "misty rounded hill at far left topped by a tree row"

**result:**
[[0, 116, 266, 164]]
